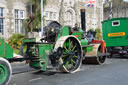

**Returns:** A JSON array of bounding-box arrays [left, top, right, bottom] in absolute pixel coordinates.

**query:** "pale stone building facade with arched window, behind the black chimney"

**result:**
[[44, 0, 103, 30]]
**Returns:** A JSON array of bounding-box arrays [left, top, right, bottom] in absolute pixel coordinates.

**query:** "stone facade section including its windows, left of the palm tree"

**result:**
[[0, 0, 27, 39]]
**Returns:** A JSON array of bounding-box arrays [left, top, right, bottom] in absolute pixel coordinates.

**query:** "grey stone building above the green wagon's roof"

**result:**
[[103, 0, 128, 20]]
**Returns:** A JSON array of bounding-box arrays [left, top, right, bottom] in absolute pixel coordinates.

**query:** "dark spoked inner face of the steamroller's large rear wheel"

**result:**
[[62, 38, 81, 72]]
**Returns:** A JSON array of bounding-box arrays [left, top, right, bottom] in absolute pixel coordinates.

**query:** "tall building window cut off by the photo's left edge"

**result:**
[[0, 7, 4, 35]]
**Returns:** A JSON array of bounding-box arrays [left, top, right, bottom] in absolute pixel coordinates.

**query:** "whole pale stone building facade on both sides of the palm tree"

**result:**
[[0, 0, 103, 39]]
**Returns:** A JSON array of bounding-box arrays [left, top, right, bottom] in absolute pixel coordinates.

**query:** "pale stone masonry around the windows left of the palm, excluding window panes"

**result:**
[[0, 0, 27, 39]]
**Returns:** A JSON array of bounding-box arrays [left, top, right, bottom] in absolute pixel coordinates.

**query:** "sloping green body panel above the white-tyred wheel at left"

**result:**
[[0, 38, 13, 59]]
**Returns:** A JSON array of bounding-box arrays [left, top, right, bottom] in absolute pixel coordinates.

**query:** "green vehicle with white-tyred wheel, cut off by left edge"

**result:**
[[0, 38, 13, 85]]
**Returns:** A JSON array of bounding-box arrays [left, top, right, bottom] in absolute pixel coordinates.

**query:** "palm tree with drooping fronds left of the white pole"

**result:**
[[24, 0, 47, 36]]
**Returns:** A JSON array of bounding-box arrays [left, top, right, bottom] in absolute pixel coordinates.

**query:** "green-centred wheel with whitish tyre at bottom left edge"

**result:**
[[0, 58, 12, 85]]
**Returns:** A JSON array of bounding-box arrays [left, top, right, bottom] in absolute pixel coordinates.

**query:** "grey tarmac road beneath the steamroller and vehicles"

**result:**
[[9, 58, 128, 85]]
